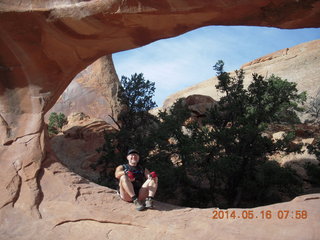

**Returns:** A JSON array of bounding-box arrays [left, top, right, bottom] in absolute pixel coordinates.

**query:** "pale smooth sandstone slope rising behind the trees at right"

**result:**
[[163, 40, 320, 108]]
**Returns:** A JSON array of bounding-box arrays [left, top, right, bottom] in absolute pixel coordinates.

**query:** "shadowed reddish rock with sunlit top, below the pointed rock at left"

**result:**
[[50, 113, 116, 182]]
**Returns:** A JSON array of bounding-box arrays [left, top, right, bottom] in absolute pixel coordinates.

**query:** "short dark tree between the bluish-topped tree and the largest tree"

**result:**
[[154, 99, 201, 207]]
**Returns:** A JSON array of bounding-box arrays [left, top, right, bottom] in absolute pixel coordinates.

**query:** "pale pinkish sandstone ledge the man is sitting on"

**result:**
[[0, 147, 320, 240]]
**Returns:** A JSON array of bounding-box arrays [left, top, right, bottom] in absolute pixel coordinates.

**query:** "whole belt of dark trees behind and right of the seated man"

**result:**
[[98, 61, 320, 208]]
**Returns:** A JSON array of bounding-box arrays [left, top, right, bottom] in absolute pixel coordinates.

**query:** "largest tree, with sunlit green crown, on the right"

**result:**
[[201, 61, 306, 207]]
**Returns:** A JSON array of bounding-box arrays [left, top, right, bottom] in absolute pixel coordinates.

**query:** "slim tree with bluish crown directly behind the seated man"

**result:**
[[93, 73, 158, 187]]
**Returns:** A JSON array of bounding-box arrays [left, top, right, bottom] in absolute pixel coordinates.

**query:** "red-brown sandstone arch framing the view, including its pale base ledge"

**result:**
[[0, 0, 320, 239]]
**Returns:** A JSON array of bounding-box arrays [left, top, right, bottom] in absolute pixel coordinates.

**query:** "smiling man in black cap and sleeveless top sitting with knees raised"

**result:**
[[115, 149, 158, 211]]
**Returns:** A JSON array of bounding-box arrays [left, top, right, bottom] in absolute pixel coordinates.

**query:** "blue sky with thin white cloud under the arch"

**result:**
[[113, 26, 320, 106]]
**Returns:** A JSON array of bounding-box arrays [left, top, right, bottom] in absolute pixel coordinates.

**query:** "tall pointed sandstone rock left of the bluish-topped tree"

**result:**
[[46, 55, 122, 123]]
